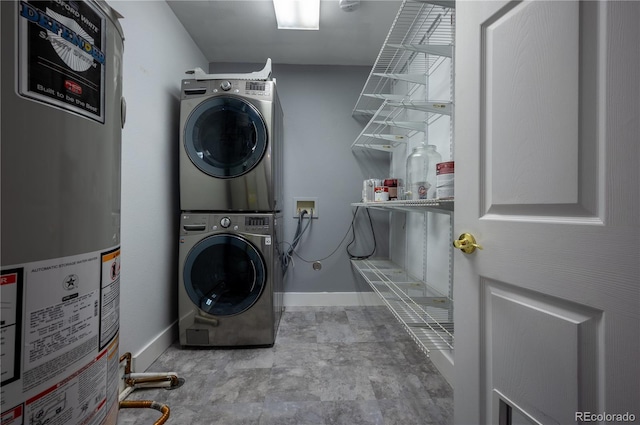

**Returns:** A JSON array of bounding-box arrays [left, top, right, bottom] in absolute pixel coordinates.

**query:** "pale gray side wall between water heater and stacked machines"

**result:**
[[111, 1, 207, 372]]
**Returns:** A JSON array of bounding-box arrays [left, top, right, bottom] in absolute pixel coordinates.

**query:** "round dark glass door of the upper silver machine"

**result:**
[[184, 96, 267, 178]]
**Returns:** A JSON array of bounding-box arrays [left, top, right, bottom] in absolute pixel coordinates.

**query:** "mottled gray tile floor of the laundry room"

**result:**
[[118, 307, 453, 425]]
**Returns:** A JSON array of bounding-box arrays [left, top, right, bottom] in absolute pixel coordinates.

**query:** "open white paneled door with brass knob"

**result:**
[[454, 0, 640, 425]]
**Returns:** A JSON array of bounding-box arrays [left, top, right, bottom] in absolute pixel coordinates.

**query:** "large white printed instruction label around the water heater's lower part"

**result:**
[[0, 246, 120, 425]]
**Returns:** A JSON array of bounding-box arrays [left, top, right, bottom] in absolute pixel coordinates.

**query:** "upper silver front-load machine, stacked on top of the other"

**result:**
[[180, 79, 283, 212]]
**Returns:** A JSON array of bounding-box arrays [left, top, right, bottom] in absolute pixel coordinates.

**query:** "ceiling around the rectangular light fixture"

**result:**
[[167, 0, 401, 66]]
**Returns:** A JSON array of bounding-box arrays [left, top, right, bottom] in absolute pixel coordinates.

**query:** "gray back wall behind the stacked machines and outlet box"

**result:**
[[209, 63, 389, 292]]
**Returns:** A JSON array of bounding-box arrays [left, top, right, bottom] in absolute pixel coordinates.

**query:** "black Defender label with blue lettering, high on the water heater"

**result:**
[[17, 0, 106, 123]]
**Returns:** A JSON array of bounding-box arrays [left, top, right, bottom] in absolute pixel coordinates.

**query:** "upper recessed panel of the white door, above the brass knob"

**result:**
[[480, 1, 605, 219]]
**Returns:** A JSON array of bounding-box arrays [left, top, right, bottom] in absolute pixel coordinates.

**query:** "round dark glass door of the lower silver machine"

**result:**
[[183, 234, 267, 316]]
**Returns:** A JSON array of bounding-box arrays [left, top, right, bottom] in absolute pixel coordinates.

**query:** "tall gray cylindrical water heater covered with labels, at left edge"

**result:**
[[0, 0, 124, 425]]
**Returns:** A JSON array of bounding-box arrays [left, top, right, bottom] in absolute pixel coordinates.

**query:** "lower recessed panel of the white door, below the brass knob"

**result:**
[[480, 278, 605, 424]]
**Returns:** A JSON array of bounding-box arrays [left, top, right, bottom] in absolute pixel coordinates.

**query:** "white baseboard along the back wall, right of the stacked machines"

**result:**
[[283, 292, 383, 307]]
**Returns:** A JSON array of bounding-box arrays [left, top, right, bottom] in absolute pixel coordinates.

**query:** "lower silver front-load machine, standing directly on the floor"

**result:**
[[178, 212, 283, 347]]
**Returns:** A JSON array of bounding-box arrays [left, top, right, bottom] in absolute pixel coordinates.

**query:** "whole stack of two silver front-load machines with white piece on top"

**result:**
[[178, 60, 283, 347]]
